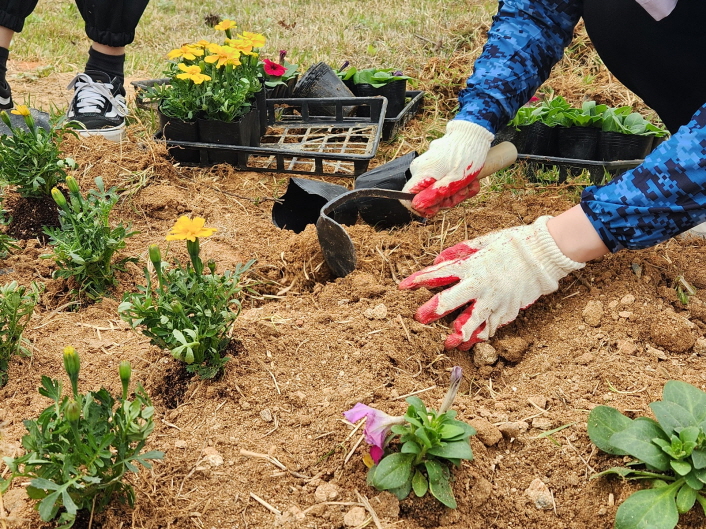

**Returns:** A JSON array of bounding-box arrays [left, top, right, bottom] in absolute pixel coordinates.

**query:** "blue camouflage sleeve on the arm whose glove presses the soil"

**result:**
[[581, 104, 706, 252]]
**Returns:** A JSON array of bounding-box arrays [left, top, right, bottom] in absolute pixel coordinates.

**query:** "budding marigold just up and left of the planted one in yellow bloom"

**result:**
[[42, 176, 138, 301]]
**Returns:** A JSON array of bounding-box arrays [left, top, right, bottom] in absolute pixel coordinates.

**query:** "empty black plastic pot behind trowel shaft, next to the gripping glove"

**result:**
[[355, 151, 422, 230]]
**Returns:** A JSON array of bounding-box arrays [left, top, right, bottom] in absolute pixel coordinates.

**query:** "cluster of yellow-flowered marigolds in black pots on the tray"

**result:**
[[148, 20, 265, 163]]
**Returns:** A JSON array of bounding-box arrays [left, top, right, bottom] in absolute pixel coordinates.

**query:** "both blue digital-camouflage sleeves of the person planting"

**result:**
[[455, 0, 706, 252]]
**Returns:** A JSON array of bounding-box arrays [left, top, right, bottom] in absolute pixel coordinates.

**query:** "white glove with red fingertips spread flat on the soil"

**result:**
[[399, 216, 585, 350]]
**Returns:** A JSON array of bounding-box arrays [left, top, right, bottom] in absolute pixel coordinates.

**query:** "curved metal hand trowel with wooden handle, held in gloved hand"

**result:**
[[316, 142, 517, 277]]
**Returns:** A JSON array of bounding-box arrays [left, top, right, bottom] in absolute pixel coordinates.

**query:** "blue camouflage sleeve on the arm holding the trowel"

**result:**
[[455, 0, 583, 133]]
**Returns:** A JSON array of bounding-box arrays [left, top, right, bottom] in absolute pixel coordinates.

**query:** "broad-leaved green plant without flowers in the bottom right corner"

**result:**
[[588, 380, 706, 529]]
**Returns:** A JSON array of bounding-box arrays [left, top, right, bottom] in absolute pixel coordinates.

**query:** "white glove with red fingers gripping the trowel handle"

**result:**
[[403, 119, 494, 217]]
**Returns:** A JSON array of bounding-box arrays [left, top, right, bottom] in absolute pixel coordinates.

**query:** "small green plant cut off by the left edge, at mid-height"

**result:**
[[0, 281, 44, 388]]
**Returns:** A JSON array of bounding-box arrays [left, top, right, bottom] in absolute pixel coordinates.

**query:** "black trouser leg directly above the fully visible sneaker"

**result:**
[[76, 0, 149, 47]]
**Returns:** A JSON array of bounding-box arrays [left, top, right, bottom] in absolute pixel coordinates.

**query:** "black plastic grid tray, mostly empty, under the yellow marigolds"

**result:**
[[155, 97, 387, 177]]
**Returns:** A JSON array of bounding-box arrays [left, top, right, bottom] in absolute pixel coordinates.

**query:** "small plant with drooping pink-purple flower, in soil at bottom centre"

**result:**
[[343, 367, 476, 509]]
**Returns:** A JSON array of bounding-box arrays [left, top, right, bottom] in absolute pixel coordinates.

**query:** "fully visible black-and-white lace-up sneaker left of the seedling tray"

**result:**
[[66, 71, 127, 141]]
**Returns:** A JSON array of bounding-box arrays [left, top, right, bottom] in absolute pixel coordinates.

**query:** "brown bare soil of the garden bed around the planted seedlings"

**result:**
[[0, 129, 706, 529]]
